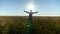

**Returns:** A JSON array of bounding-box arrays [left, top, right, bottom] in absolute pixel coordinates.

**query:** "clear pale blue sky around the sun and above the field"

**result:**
[[0, 0, 60, 16]]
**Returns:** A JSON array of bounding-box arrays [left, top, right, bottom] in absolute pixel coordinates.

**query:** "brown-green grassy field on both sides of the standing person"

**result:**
[[0, 16, 60, 34]]
